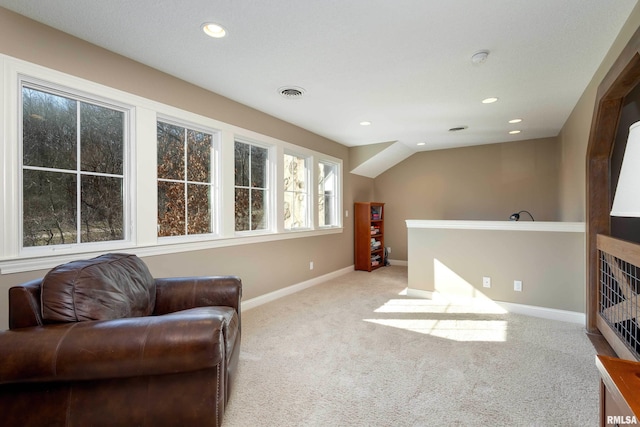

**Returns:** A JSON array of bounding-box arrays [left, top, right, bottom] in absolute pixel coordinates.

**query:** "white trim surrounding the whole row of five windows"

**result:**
[[0, 54, 344, 274]]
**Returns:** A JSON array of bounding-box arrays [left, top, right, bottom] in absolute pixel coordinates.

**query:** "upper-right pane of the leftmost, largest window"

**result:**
[[80, 102, 124, 175]]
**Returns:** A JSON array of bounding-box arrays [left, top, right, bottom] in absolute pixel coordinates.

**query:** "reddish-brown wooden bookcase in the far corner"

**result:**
[[354, 202, 386, 271]]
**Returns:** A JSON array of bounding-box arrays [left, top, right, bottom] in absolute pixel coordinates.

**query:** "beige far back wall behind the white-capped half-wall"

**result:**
[[374, 138, 558, 260]]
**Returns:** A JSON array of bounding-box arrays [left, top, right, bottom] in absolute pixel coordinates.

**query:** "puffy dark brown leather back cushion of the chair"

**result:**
[[41, 254, 156, 322]]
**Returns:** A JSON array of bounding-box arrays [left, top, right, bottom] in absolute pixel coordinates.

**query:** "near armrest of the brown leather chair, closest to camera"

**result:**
[[0, 307, 225, 384]]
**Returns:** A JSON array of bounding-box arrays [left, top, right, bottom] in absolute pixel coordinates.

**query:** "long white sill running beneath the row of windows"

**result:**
[[0, 227, 343, 275]]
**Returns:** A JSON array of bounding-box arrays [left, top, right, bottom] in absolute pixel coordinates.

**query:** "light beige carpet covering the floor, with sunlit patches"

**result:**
[[223, 266, 599, 427]]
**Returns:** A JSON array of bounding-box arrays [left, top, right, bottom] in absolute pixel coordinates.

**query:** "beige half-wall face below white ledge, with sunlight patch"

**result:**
[[409, 228, 586, 313]]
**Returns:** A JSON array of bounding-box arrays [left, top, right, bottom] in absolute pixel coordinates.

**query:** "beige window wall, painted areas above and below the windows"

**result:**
[[0, 8, 360, 329]]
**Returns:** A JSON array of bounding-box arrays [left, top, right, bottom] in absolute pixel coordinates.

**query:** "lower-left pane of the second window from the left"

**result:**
[[158, 181, 185, 237]]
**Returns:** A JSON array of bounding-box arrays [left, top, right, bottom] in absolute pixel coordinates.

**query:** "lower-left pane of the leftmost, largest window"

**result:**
[[22, 170, 77, 247]]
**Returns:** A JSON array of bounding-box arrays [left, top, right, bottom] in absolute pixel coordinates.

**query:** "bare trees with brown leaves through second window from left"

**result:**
[[157, 121, 213, 237]]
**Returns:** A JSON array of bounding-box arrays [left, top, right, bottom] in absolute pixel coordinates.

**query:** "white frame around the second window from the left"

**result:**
[[154, 114, 221, 243]]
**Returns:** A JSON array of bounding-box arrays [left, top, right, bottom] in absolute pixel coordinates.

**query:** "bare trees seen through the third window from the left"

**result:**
[[235, 141, 269, 231]]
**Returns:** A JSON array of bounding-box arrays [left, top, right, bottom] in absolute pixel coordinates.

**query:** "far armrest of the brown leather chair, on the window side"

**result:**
[[154, 276, 242, 318]]
